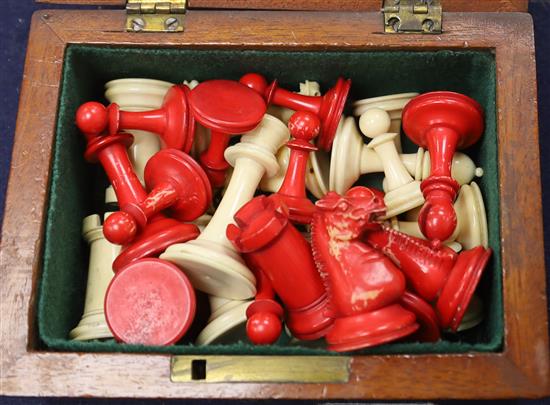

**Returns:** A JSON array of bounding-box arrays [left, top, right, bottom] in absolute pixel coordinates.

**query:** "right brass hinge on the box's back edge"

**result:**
[[382, 0, 442, 34]]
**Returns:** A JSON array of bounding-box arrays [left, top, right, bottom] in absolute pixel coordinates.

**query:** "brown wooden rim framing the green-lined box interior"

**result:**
[[0, 10, 550, 399]]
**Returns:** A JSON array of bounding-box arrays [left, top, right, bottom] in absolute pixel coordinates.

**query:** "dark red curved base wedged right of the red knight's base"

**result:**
[[399, 291, 441, 342]]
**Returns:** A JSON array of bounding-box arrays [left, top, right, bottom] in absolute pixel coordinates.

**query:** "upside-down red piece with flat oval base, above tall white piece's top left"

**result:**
[[189, 80, 267, 187]]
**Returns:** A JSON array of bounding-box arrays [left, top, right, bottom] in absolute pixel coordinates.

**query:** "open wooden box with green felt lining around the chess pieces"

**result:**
[[0, 0, 550, 399]]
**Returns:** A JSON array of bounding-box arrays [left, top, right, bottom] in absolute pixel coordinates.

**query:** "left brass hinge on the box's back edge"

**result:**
[[126, 0, 186, 32]]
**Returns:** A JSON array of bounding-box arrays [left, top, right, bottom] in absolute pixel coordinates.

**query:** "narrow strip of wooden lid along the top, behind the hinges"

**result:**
[[36, 0, 528, 12]]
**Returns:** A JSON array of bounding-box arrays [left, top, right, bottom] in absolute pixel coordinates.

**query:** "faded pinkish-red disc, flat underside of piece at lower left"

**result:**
[[105, 259, 196, 346]]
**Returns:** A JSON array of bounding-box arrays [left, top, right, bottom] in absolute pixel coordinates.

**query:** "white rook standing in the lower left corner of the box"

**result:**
[[69, 213, 121, 340]]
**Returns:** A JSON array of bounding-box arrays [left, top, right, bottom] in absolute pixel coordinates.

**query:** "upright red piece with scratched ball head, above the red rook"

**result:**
[[277, 111, 321, 224]]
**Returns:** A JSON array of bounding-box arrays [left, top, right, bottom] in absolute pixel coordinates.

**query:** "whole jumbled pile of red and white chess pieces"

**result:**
[[70, 73, 492, 352]]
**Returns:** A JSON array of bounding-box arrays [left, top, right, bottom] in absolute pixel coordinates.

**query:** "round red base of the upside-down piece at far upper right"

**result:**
[[403, 91, 484, 149]]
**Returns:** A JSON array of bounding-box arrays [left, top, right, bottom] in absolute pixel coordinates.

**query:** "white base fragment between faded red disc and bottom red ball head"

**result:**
[[196, 301, 252, 346]]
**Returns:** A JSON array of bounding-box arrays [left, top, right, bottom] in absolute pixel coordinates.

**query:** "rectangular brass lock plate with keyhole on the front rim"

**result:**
[[170, 356, 351, 384]]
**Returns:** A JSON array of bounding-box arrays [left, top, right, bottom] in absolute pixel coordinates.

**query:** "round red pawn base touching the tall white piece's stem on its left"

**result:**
[[143, 149, 212, 221]]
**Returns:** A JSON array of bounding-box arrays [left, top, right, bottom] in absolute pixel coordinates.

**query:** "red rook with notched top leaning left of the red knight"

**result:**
[[227, 194, 332, 340]]
